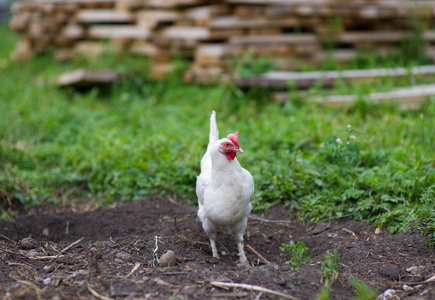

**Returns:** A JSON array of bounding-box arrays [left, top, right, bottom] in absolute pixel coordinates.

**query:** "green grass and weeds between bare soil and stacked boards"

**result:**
[[0, 26, 435, 243]]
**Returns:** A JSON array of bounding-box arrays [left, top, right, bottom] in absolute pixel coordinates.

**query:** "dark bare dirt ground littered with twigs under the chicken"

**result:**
[[0, 197, 435, 299]]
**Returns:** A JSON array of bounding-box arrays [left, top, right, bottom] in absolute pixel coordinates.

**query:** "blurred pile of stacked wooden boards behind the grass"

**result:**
[[10, 0, 435, 82]]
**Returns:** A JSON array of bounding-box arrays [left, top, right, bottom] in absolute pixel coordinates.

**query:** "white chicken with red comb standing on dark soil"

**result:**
[[196, 111, 254, 264]]
